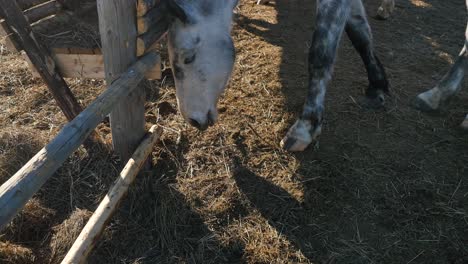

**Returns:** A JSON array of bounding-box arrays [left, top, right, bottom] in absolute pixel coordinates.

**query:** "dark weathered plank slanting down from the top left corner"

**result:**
[[0, 0, 82, 120]]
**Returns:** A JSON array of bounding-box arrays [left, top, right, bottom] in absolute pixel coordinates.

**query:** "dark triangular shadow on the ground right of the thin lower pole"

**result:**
[[89, 137, 249, 263]]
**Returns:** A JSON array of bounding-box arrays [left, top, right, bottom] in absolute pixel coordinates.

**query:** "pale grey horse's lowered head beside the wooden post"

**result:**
[[166, 0, 238, 130]]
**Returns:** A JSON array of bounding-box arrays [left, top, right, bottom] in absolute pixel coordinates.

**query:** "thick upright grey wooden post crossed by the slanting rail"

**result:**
[[97, 0, 145, 161]]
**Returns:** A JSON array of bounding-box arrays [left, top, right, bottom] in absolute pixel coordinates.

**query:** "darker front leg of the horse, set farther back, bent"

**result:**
[[346, 0, 388, 108]]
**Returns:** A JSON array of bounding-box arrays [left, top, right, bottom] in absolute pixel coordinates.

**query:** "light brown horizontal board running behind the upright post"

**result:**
[[23, 49, 161, 80]]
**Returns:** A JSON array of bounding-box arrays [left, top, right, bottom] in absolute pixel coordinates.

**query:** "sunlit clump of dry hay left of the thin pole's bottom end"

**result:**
[[50, 209, 93, 263]]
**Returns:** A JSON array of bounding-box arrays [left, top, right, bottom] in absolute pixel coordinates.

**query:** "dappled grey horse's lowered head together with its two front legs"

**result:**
[[166, 0, 388, 151]]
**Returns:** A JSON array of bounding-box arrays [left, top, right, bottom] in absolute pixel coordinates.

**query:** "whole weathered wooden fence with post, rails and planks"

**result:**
[[0, 0, 169, 263]]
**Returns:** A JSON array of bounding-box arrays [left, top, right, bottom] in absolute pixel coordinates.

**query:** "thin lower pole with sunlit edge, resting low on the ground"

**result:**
[[62, 126, 162, 264]]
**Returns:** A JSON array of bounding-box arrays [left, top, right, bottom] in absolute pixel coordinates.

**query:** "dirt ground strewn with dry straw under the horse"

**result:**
[[0, 0, 468, 264]]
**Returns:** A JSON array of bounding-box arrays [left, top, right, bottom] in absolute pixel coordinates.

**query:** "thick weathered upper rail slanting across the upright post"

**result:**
[[0, 52, 159, 230]]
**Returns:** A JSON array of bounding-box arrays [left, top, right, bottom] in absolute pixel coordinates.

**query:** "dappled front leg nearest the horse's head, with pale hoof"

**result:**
[[281, 0, 350, 151]]
